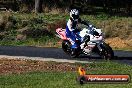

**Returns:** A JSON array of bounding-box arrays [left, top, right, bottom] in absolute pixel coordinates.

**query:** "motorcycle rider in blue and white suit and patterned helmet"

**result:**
[[66, 9, 88, 55]]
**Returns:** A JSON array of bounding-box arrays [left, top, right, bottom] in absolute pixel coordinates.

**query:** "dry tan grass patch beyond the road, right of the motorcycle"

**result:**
[[105, 37, 132, 49]]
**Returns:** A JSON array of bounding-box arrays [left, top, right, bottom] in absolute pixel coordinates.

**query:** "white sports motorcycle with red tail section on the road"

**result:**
[[56, 25, 114, 60]]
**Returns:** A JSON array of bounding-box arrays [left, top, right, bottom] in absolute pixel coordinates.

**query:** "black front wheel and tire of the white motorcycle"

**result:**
[[99, 43, 114, 60]]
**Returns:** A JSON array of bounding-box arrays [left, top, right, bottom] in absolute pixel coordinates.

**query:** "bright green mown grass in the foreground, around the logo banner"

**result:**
[[0, 62, 132, 88]]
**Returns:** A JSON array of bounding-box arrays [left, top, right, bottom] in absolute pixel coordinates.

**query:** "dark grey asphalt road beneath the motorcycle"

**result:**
[[0, 46, 132, 65]]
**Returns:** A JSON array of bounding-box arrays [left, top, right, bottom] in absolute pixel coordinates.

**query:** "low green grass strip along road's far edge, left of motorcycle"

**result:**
[[0, 36, 59, 47]]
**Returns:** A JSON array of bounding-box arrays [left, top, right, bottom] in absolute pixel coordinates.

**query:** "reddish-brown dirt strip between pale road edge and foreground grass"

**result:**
[[0, 58, 78, 75]]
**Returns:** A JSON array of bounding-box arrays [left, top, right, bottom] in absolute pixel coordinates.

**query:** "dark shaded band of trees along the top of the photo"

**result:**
[[0, 0, 132, 14]]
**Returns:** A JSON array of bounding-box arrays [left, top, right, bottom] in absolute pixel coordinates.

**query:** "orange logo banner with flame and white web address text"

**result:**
[[77, 67, 130, 84]]
